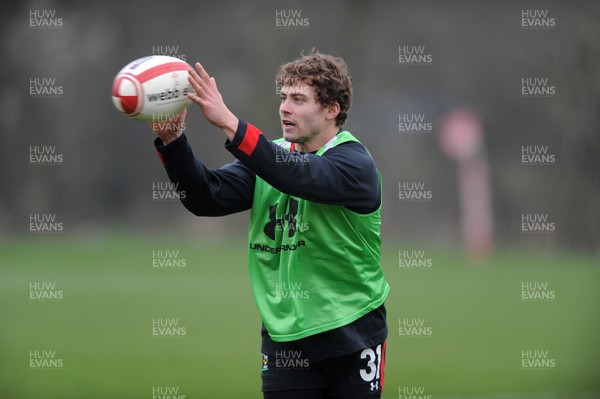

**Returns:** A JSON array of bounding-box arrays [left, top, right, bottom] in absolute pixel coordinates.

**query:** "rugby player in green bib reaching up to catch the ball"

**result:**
[[151, 51, 389, 399]]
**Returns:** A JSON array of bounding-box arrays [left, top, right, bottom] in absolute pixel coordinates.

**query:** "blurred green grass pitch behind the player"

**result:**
[[0, 234, 600, 399]]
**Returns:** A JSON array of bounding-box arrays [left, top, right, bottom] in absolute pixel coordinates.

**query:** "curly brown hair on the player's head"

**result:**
[[275, 49, 352, 126]]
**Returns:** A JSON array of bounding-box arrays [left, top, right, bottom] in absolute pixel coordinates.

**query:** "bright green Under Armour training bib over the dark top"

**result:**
[[249, 131, 389, 341]]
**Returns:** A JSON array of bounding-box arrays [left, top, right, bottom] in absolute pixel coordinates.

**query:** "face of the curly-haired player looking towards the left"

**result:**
[[279, 83, 335, 144]]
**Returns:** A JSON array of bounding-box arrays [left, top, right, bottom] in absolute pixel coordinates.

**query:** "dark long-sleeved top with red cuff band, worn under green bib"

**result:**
[[154, 120, 387, 362]]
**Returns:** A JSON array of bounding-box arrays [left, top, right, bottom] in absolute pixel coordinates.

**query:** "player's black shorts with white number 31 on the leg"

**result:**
[[262, 342, 385, 399]]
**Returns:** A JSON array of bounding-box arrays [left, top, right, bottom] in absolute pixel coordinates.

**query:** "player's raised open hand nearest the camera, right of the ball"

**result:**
[[188, 62, 239, 141]]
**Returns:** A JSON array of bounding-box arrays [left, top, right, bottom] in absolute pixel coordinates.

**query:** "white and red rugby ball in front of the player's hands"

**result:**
[[112, 55, 192, 122]]
